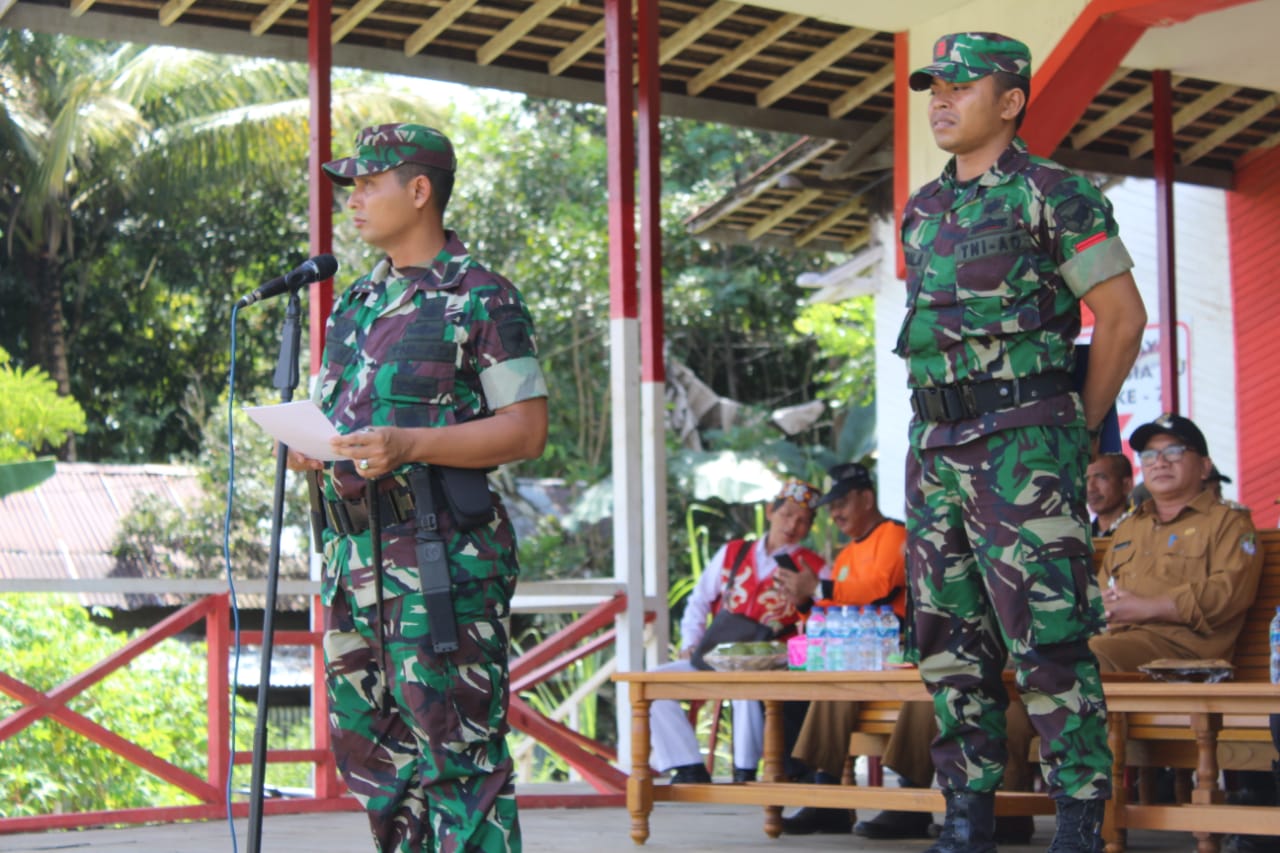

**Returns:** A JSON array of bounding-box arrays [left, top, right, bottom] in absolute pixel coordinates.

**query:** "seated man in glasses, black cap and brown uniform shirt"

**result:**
[[1089, 415, 1262, 672]]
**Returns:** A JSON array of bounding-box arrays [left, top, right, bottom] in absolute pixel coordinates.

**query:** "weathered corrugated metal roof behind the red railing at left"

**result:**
[[0, 462, 200, 607]]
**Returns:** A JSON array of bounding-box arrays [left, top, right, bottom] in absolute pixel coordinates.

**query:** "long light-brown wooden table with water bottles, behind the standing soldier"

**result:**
[[614, 670, 1280, 853]]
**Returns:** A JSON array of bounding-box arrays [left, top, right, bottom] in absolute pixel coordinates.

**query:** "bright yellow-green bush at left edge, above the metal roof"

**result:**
[[0, 347, 84, 462]]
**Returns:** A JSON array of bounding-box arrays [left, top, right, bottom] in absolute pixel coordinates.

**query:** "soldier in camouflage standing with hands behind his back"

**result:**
[[896, 33, 1146, 853]]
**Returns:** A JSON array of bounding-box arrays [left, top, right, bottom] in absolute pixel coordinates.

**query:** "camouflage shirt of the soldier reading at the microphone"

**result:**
[[315, 232, 547, 606]]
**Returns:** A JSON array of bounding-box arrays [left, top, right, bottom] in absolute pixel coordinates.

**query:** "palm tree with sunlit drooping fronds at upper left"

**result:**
[[0, 31, 424, 459]]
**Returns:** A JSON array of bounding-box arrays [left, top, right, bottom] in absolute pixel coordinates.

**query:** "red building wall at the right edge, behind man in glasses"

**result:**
[[1226, 147, 1280, 528]]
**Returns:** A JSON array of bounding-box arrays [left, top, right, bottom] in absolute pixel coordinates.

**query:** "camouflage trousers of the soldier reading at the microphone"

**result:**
[[324, 578, 521, 853]]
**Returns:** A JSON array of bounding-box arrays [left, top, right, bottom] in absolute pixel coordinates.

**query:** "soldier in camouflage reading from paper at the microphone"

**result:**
[[289, 124, 547, 853]]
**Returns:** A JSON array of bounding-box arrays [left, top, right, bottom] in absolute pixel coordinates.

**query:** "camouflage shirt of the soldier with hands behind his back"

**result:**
[[895, 138, 1133, 447]]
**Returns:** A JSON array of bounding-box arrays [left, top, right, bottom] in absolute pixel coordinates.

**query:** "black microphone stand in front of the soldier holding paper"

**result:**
[[245, 288, 302, 853]]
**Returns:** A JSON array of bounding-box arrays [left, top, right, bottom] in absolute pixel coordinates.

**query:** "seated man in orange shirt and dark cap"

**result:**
[[778, 462, 906, 835]]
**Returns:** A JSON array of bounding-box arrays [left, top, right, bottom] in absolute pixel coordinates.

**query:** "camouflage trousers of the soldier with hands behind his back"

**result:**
[[906, 427, 1111, 799]]
